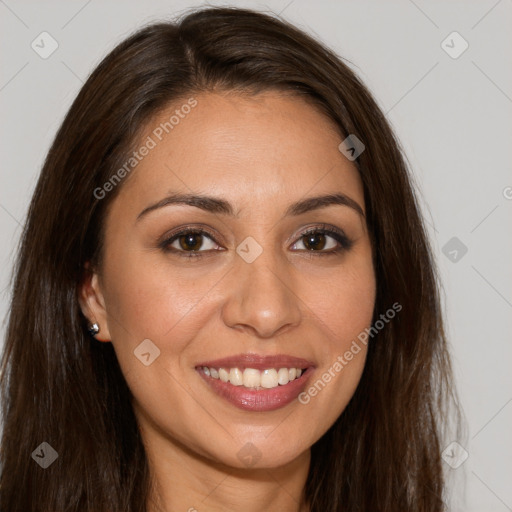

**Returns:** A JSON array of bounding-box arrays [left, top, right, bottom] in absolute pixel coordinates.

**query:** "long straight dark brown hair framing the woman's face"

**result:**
[[0, 8, 460, 512]]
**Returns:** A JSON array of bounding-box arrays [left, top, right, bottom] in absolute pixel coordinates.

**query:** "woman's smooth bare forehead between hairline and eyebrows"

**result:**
[[118, 91, 364, 215]]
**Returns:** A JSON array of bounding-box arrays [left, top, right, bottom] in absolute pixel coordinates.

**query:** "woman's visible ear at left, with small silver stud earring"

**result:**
[[78, 264, 111, 342]]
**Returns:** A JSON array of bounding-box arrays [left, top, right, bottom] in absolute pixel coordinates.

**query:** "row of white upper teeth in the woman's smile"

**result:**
[[202, 366, 302, 390]]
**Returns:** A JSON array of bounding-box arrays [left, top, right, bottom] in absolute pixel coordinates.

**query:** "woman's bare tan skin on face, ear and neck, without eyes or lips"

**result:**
[[80, 92, 376, 512]]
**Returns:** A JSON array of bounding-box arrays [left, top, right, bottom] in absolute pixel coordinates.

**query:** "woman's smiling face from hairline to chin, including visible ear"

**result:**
[[81, 92, 375, 468]]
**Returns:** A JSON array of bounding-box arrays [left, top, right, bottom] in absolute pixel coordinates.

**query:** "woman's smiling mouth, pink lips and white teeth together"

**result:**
[[196, 354, 314, 411]]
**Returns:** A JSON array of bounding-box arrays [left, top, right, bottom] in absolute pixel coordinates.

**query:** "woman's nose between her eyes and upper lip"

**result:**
[[222, 251, 301, 338]]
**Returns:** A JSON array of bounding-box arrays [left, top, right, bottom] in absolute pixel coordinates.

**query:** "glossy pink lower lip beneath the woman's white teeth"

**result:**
[[197, 368, 313, 412]]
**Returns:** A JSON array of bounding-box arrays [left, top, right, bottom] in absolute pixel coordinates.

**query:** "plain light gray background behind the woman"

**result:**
[[0, 0, 512, 512]]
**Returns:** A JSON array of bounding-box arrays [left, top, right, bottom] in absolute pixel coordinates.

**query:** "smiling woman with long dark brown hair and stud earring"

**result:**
[[0, 8, 451, 512]]
